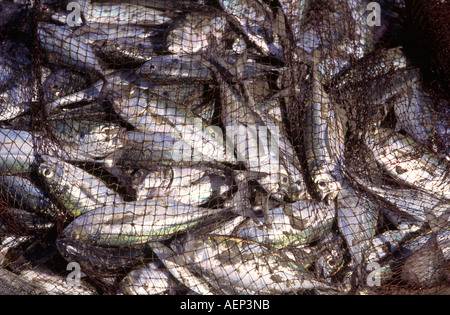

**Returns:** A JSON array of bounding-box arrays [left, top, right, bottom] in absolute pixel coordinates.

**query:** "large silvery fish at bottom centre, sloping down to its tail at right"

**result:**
[[171, 235, 340, 295]]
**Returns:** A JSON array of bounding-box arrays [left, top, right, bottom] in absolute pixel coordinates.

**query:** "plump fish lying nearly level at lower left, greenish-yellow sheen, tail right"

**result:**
[[59, 197, 229, 246]]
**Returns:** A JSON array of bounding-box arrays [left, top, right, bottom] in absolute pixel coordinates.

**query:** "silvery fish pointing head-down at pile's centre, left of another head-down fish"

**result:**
[[218, 72, 303, 201]]
